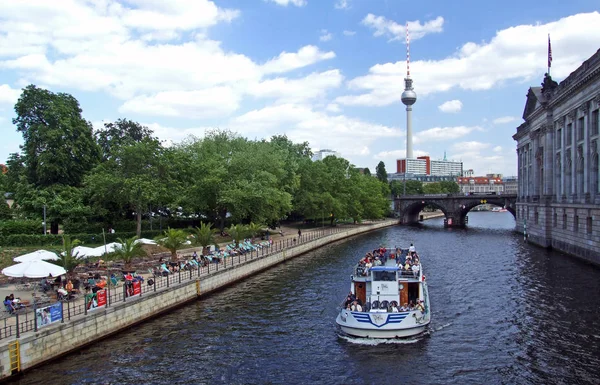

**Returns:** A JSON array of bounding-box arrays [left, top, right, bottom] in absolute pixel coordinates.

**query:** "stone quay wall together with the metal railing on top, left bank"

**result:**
[[0, 220, 398, 379]]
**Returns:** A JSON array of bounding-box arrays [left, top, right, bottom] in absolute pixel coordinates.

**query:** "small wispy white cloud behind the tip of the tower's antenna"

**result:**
[[361, 13, 444, 41]]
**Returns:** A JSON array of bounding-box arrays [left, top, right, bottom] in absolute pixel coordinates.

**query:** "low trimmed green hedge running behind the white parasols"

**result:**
[[0, 230, 169, 247]]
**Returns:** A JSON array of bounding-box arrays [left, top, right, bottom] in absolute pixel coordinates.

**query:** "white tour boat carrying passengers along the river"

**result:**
[[336, 244, 431, 338]]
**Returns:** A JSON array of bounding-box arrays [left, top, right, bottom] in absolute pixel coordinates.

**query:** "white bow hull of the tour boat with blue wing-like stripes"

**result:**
[[336, 310, 430, 338]]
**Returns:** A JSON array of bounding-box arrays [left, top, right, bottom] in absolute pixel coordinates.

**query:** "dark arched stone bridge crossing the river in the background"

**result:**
[[394, 193, 517, 227]]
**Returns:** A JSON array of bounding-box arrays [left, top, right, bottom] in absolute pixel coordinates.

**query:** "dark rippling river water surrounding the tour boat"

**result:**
[[16, 212, 600, 384]]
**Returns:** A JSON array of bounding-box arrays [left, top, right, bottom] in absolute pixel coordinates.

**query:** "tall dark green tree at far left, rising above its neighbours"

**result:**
[[13, 85, 99, 187]]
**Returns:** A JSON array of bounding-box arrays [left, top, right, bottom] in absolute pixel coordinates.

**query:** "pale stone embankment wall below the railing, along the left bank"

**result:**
[[0, 220, 398, 379]]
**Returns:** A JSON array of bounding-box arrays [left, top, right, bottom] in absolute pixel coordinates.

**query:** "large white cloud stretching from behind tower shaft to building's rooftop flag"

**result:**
[[336, 12, 600, 106]]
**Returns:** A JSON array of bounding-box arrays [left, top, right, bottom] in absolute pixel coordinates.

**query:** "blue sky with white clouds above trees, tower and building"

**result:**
[[0, 0, 600, 176]]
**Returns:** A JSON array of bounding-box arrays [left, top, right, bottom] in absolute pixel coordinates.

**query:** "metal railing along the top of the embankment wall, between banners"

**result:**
[[0, 227, 356, 339]]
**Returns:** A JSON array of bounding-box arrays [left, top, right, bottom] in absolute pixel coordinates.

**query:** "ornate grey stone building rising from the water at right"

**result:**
[[513, 50, 600, 264]]
